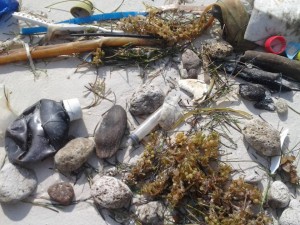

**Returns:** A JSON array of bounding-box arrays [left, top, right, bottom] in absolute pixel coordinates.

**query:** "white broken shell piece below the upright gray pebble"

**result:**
[[178, 79, 207, 101]]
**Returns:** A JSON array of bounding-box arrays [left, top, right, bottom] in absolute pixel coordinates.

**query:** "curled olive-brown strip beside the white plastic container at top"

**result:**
[[212, 0, 257, 51]]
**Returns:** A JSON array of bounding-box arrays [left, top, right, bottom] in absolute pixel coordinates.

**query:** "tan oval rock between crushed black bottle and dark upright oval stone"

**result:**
[[54, 138, 95, 172]]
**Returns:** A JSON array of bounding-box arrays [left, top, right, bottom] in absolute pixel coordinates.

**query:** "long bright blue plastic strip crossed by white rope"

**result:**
[[21, 11, 148, 35]]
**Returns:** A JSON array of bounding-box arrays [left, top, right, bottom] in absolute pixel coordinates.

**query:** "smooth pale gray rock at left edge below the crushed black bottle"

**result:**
[[0, 163, 37, 203]]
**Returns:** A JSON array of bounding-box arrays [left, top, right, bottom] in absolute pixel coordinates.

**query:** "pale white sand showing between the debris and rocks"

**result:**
[[0, 0, 300, 225]]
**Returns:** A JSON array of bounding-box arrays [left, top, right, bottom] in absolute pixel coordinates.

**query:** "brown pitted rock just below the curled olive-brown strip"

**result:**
[[202, 39, 233, 59]]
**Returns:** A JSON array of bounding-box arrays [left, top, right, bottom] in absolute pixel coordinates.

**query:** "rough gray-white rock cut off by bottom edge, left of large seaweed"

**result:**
[[135, 201, 166, 225]]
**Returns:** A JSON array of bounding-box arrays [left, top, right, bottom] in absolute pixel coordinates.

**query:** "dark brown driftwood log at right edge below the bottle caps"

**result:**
[[240, 51, 300, 81]]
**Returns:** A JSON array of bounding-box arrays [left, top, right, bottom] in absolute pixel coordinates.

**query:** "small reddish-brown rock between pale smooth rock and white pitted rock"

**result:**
[[48, 182, 75, 205]]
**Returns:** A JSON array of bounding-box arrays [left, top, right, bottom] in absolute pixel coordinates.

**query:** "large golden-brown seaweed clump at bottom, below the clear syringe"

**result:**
[[127, 132, 270, 225]]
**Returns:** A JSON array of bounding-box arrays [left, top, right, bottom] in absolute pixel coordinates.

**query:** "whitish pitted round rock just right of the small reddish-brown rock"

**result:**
[[91, 176, 132, 209]]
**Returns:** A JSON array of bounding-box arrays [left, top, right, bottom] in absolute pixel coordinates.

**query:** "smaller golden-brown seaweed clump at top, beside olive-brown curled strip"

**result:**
[[119, 6, 214, 45]]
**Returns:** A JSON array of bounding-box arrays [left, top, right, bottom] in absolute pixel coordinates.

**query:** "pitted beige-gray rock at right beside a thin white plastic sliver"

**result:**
[[243, 119, 281, 156]]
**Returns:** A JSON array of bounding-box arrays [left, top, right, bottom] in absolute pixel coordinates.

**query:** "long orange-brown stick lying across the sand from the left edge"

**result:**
[[0, 37, 159, 65]]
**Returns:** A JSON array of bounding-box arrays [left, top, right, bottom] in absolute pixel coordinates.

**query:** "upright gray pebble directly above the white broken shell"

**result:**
[[182, 49, 201, 79]]
